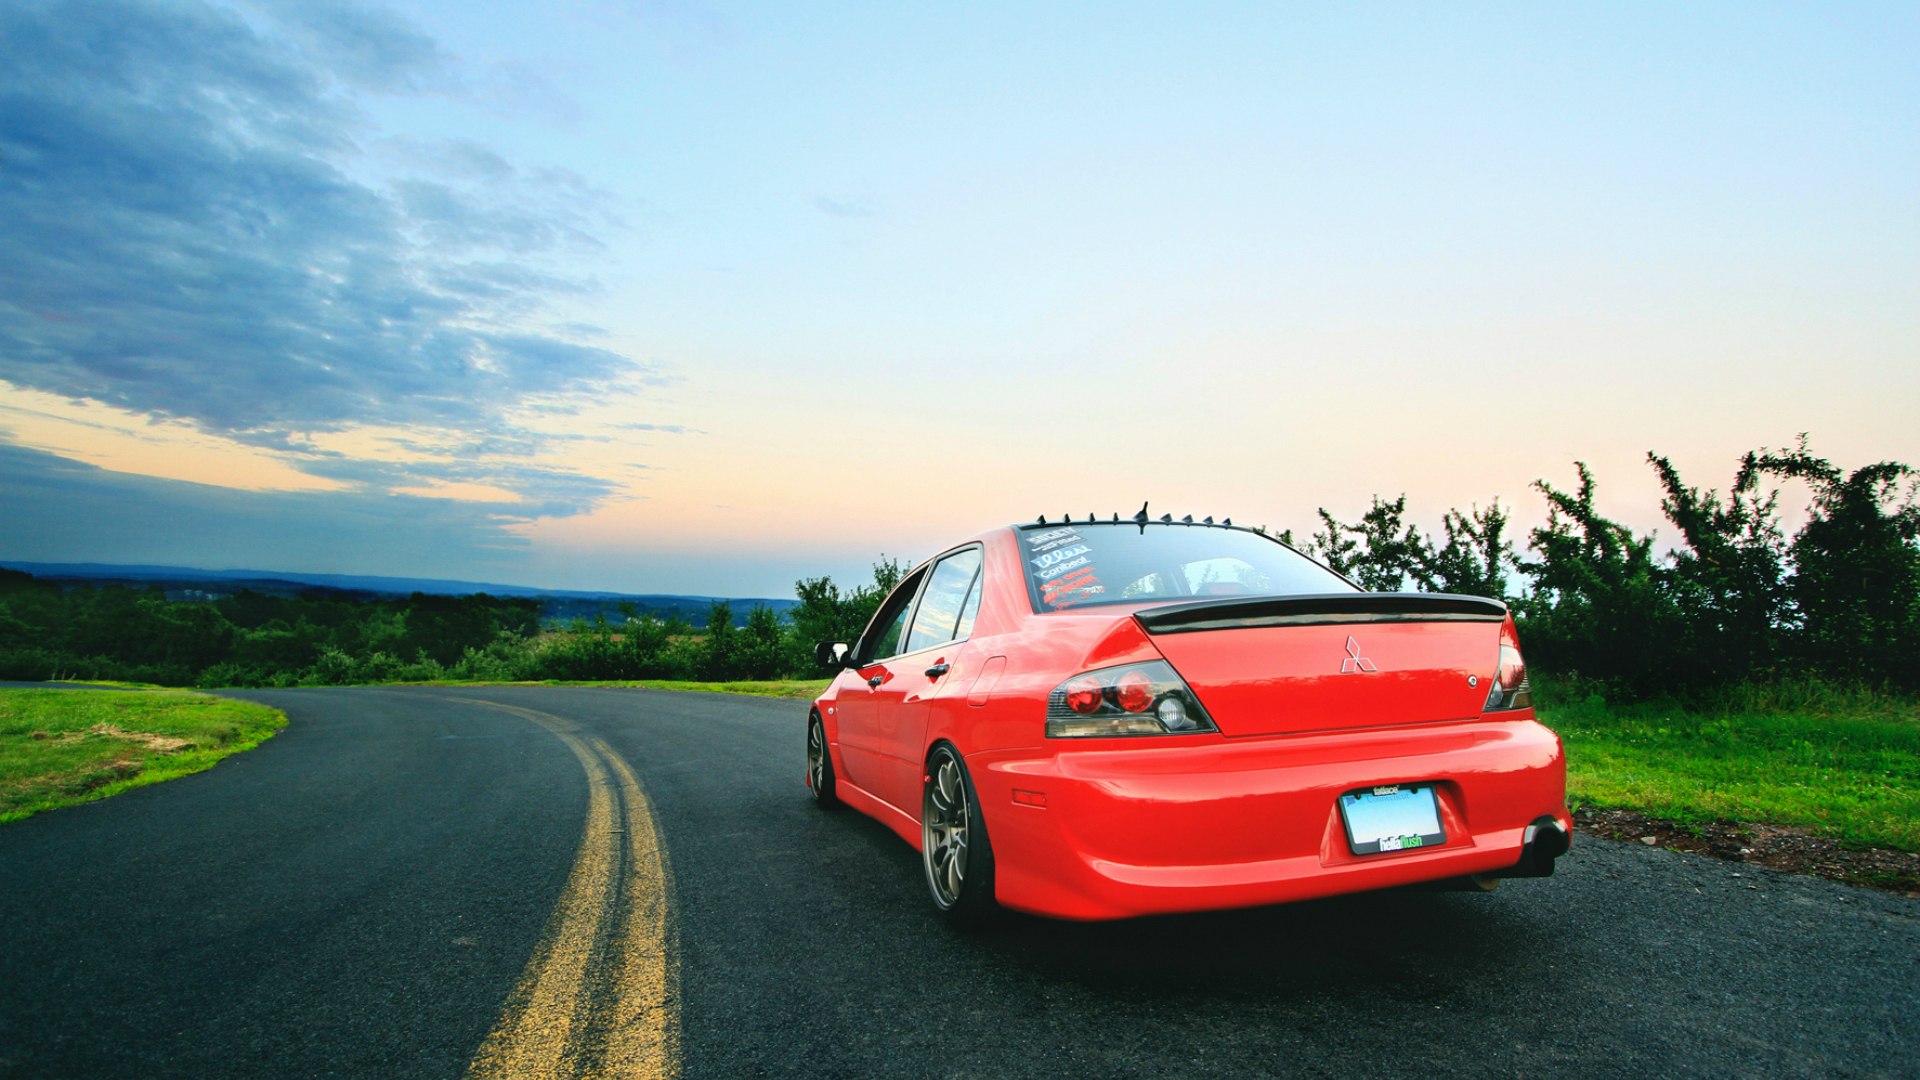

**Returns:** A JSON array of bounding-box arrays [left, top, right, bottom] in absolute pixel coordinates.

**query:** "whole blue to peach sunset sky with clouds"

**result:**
[[0, 0, 1920, 596]]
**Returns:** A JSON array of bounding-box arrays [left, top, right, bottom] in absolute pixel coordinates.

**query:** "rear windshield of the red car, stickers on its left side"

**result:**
[[1020, 523, 1357, 611]]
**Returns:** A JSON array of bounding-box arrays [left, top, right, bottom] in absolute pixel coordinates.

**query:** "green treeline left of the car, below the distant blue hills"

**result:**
[[0, 559, 904, 688]]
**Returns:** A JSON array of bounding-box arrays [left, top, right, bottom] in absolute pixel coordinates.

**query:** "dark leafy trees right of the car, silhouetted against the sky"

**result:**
[[1284, 436, 1920, 698]]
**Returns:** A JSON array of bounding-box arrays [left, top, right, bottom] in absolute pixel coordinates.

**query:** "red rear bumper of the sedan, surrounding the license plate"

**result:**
[[968, 719, 1572, 919]]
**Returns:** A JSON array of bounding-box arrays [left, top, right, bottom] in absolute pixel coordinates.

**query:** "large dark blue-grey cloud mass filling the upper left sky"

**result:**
[[0, 0, 659, 511]]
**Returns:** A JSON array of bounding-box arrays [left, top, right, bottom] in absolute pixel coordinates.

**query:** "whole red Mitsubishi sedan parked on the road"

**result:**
[[806, 509, 1572, 922]]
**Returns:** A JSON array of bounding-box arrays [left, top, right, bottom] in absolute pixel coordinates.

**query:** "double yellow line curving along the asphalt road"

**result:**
[[451, 698, 680, 1080]]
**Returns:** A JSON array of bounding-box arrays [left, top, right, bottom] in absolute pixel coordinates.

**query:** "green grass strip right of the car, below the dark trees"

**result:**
[[1536, 682, 1920, 851]]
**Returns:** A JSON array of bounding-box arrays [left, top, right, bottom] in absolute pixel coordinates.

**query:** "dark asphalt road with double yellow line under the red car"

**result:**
[[0, 688, 1920, 1078]]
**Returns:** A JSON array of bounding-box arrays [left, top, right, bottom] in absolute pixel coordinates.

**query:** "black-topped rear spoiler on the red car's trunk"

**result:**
[[1133, 592, 1507, 634]]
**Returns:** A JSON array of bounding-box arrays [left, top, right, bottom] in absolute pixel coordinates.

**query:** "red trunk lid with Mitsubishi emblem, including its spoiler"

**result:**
[[1135, 592, 1507, 736]]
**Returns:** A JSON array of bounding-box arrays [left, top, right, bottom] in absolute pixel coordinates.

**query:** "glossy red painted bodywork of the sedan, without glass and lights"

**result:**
[[820, 528, 1572, 919]]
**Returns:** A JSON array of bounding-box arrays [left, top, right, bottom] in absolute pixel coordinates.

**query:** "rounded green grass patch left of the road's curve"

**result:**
[[0, 690, 286, 822]]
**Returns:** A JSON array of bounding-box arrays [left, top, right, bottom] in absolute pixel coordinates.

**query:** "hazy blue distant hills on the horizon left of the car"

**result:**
[[0, 559, 799, 626]]
